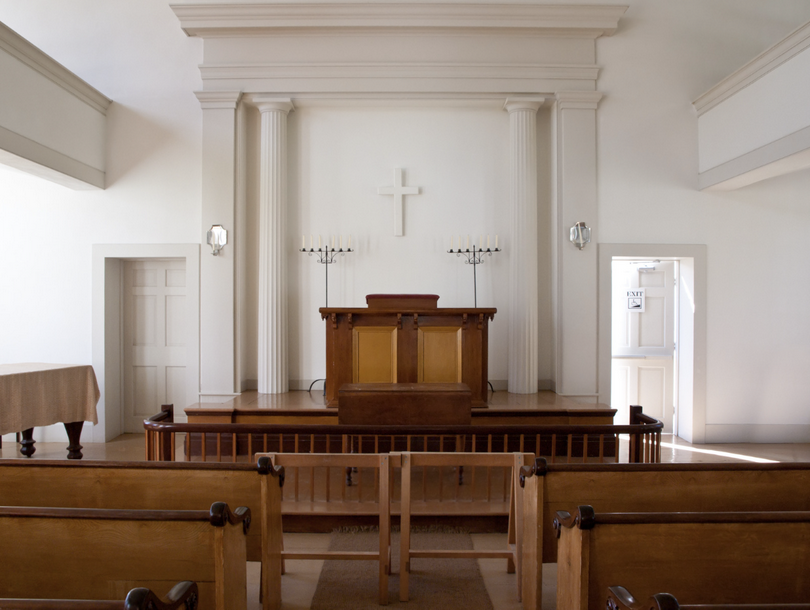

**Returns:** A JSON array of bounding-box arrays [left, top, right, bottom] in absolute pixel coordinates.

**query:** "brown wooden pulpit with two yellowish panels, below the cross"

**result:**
[[319, 294, 497, 407]]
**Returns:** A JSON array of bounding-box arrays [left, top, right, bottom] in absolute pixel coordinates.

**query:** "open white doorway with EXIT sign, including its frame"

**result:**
[[598, 244, 706, 443]]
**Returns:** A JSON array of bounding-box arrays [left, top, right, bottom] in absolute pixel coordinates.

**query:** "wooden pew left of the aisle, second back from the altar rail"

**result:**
[[0, 502, 250, 610]]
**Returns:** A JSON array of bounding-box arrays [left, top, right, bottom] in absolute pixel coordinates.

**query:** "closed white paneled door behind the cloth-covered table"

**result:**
[[123, 259, 186, 432]]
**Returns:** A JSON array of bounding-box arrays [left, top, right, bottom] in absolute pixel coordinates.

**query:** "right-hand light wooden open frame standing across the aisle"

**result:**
[[397, 452, 534, 602]]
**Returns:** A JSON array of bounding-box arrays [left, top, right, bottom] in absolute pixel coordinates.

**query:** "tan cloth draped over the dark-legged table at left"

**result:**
[[0, 362, 101, 434]]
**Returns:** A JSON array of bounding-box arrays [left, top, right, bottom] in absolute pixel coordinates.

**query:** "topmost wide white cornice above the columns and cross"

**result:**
[[171, 2, 627, 38]]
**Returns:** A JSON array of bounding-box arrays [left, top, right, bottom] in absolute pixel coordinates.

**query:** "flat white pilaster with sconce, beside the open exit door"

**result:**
[[553, 91, 602, 402]]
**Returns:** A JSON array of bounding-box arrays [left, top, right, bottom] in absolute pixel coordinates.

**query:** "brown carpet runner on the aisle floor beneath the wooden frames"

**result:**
[[311, 529, 492, 610]]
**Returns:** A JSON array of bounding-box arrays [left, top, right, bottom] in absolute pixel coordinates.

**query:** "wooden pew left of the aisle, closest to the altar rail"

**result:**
[[0, 459, 279, 561]]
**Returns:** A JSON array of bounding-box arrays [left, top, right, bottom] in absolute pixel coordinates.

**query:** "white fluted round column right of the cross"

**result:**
[[504, 98, 543, 394]]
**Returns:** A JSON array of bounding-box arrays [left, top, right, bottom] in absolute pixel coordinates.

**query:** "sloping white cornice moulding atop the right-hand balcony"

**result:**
[[692, 22, 810, 116]]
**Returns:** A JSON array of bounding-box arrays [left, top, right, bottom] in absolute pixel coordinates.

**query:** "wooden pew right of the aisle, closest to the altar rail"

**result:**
[[520, 458, 810, 610]]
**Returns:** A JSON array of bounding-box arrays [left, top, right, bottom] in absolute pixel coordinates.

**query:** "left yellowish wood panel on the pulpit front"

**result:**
[[352, 326, 397, 383]]
